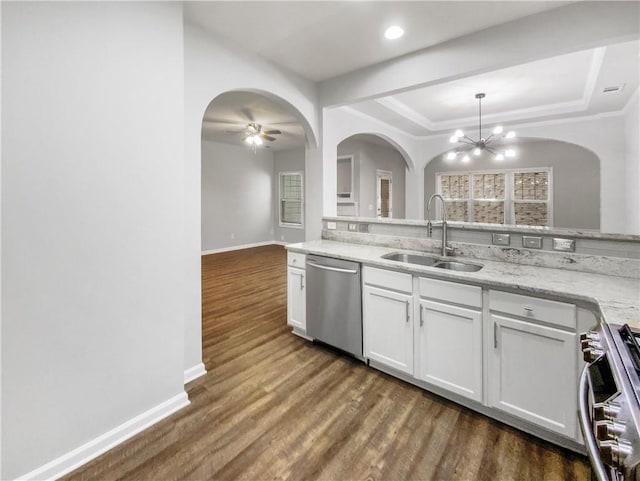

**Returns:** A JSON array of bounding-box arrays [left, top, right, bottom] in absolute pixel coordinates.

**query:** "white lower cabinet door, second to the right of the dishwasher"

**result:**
[[416, 301, 482, 402]]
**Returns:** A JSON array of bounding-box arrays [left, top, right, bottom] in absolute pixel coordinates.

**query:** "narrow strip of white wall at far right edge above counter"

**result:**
[[624, 90, 640, 234]]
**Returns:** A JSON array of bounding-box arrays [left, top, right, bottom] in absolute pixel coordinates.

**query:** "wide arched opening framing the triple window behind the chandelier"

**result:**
[[423, 138, 601, 229]]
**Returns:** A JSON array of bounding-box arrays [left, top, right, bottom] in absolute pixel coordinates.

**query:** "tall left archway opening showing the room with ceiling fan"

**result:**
[[201, 90, 316, 253]]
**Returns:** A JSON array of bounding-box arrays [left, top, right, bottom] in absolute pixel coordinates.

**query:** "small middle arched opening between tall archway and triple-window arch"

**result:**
[[336, 133, 411, 219]]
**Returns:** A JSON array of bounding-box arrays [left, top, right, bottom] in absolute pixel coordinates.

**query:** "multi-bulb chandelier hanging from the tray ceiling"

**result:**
[[446, 93, 516, 162]]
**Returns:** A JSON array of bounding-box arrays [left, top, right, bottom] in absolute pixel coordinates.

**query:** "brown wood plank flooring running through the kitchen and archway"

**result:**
[[65, 246, 590, 481]]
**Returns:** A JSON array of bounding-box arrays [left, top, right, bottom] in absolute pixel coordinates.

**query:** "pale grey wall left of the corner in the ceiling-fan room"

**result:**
[[202, 141, 274, 252]]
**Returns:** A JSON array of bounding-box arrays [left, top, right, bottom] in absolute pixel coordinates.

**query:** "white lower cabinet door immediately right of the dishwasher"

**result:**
[[362, 285, 413, 375]]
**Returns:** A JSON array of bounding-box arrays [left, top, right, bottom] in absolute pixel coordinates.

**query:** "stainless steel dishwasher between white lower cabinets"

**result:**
[[306, 254, 364, 361]]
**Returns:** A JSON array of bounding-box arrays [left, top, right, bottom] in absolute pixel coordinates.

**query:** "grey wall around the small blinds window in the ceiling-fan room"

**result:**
[[273, 149, 306, 244]]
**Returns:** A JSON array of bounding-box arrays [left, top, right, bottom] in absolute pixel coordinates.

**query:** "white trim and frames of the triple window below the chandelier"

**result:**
[[435, 167, 553, 227]]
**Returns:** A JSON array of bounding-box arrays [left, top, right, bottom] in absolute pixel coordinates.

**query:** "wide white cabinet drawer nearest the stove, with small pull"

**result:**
[[489, 291, 576, 329]]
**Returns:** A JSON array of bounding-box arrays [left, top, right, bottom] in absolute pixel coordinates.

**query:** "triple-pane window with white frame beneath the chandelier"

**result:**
[[436, 167, 553, 227]]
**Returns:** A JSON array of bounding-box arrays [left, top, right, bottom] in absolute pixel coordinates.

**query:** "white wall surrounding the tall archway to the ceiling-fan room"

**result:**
[[183, 22, 322, 376]]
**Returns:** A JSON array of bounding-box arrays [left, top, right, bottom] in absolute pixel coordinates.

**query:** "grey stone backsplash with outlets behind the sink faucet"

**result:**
[[322, 217, 640, 279]]
